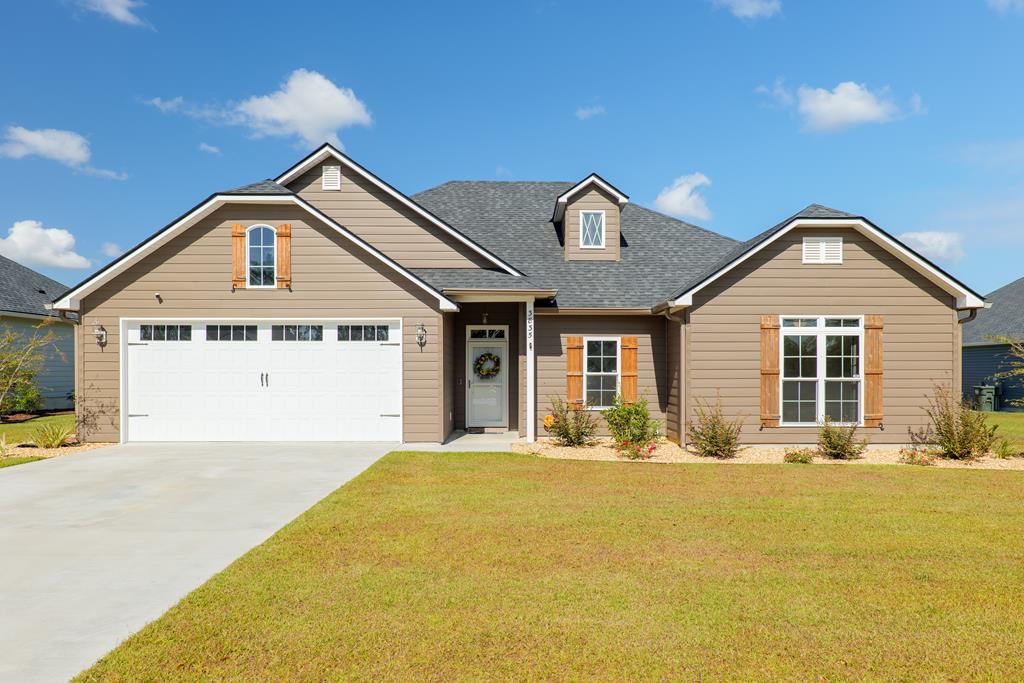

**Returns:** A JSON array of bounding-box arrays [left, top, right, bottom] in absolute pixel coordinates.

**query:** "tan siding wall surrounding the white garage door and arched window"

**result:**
[[77, 205, 442, 441]]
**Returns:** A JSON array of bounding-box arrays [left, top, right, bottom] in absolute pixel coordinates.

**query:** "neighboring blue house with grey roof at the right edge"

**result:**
[[963, 278, 1024, 411]]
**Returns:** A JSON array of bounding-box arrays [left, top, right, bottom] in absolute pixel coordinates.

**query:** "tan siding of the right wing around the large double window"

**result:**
[[685, 228, 961, 443]]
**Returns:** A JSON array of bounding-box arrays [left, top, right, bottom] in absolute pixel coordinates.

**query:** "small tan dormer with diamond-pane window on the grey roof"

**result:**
[[551, 173, 630, 261]]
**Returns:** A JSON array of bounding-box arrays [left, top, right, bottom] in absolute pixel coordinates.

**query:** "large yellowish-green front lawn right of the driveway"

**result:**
[[78, 453, 1024, 681]]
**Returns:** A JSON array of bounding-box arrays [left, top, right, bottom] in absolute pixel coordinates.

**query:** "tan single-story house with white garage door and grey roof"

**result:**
[[55, 145, 984, 443]]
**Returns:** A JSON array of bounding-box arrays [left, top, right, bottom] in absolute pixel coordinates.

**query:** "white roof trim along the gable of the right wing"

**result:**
[[669, 218, 985, 309]]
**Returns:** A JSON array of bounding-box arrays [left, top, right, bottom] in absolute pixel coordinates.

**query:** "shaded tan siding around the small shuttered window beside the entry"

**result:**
[[536, 315, 669, 436]]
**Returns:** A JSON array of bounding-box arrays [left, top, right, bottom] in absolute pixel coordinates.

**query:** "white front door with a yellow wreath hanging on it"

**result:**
[[466, 328, 509, 427]]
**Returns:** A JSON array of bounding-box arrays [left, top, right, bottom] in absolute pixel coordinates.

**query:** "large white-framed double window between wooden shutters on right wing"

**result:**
[[781, 316, 864, 425]]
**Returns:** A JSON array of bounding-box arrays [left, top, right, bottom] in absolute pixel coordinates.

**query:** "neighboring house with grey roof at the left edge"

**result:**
[[0, 256, 75, 411]]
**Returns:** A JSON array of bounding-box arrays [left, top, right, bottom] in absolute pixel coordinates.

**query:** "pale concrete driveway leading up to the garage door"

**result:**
[[0, 443, 397, 682]]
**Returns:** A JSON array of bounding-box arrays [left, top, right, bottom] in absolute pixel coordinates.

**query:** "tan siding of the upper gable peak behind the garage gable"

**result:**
[[288, 162, 495, 268]]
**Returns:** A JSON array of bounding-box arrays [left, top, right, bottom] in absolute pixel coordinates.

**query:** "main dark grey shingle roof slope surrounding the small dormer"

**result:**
[[413, 180, 737, 308]]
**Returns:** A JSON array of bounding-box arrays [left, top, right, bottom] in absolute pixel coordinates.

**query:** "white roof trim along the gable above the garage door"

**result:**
[[53, 195, 459, 311]]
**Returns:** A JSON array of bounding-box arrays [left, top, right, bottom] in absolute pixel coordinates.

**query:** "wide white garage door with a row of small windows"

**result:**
[[124, 321, 401, 441]]
